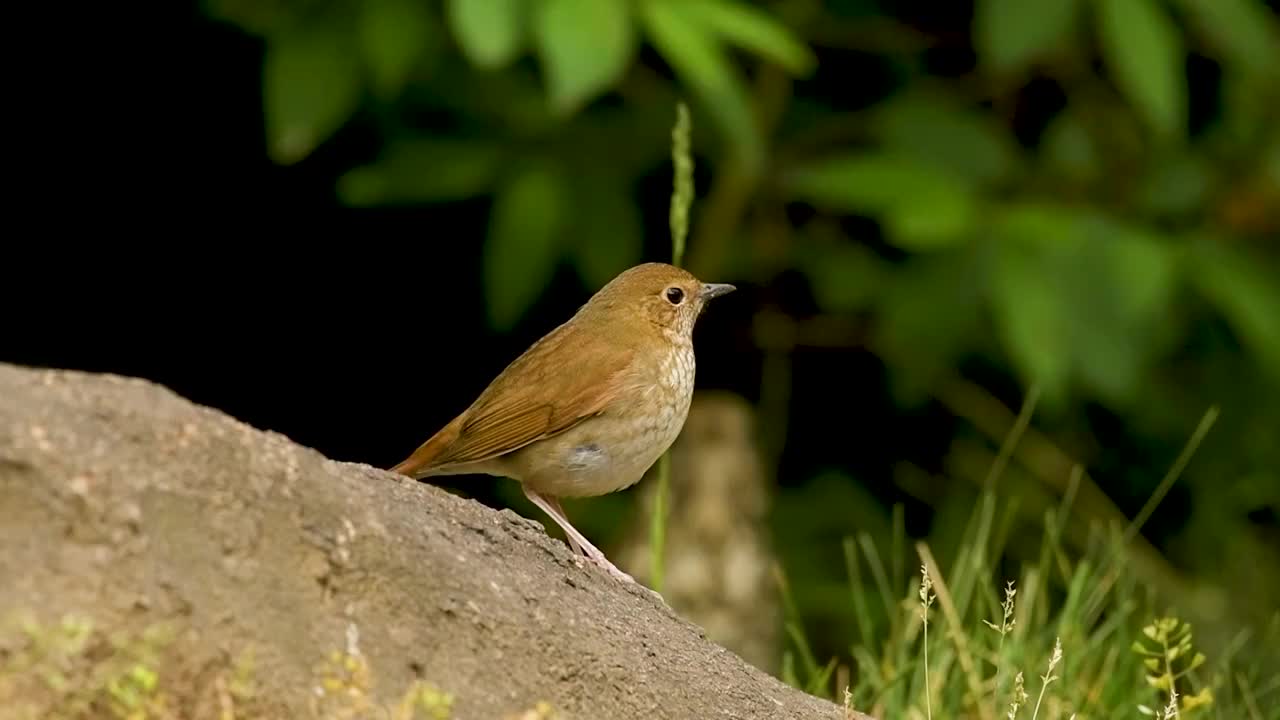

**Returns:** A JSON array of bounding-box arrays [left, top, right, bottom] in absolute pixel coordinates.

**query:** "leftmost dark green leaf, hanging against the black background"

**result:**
[[262, 22, 362, 165]]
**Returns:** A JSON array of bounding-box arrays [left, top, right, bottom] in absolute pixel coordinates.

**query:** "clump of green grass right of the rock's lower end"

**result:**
[[780, 397, 1280, 720]]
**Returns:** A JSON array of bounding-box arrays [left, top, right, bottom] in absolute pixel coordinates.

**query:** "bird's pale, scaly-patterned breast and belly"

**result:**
[[507, 342, 695, 497]]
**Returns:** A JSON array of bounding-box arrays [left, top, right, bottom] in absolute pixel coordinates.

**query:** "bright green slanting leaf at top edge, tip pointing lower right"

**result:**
[[684, 0, 818, 76]]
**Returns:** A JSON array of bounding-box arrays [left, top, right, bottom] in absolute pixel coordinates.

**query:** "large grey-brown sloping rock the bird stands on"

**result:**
[[0, 365, 870, 720]]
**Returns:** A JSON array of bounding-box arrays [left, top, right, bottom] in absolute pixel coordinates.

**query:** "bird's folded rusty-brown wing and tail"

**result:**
[[393, 320, 634, 475]]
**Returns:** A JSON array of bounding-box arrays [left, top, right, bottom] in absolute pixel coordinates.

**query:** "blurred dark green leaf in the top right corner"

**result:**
[[1181, 0, 1280, 76]]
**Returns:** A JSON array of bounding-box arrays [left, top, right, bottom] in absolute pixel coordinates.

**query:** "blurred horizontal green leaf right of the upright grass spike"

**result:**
[[787, 151, 977, 250]]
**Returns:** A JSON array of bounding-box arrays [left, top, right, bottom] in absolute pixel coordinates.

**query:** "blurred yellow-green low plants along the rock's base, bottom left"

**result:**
[[0, 614, 471, 720]]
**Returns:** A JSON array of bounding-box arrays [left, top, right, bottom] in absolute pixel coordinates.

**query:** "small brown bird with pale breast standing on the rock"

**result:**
[[392, 263, 735, 582]]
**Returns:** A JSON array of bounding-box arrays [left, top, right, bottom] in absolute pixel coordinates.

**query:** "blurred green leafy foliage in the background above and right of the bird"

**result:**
[[206, 0, 1280, 696]]
